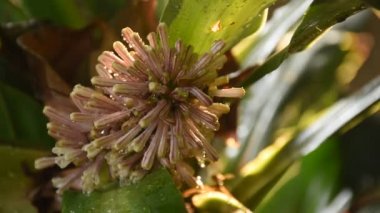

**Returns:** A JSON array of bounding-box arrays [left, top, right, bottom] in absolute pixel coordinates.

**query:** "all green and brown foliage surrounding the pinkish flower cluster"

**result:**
[[0, 0, 380, 212]]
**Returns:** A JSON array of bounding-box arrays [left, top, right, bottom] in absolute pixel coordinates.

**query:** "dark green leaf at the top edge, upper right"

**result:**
[[289, 0, 366, 53]]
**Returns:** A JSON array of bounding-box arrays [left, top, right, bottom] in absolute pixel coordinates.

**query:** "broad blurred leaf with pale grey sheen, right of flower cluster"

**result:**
[[243, 31, 368, 164]]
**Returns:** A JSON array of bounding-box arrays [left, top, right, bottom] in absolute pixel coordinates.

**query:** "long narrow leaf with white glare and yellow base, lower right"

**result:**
[[232, 77, 380, 206]]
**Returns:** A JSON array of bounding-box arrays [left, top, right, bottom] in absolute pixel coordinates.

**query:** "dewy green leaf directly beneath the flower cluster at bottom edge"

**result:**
[[62, 169, 186, 213]]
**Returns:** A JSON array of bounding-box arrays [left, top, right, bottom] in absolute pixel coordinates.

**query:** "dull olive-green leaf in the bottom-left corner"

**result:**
[[0, 146, 44, 213]]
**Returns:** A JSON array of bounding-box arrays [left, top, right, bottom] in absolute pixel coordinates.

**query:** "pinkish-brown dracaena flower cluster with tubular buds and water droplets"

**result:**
[[35, 24, 244, 192]]
